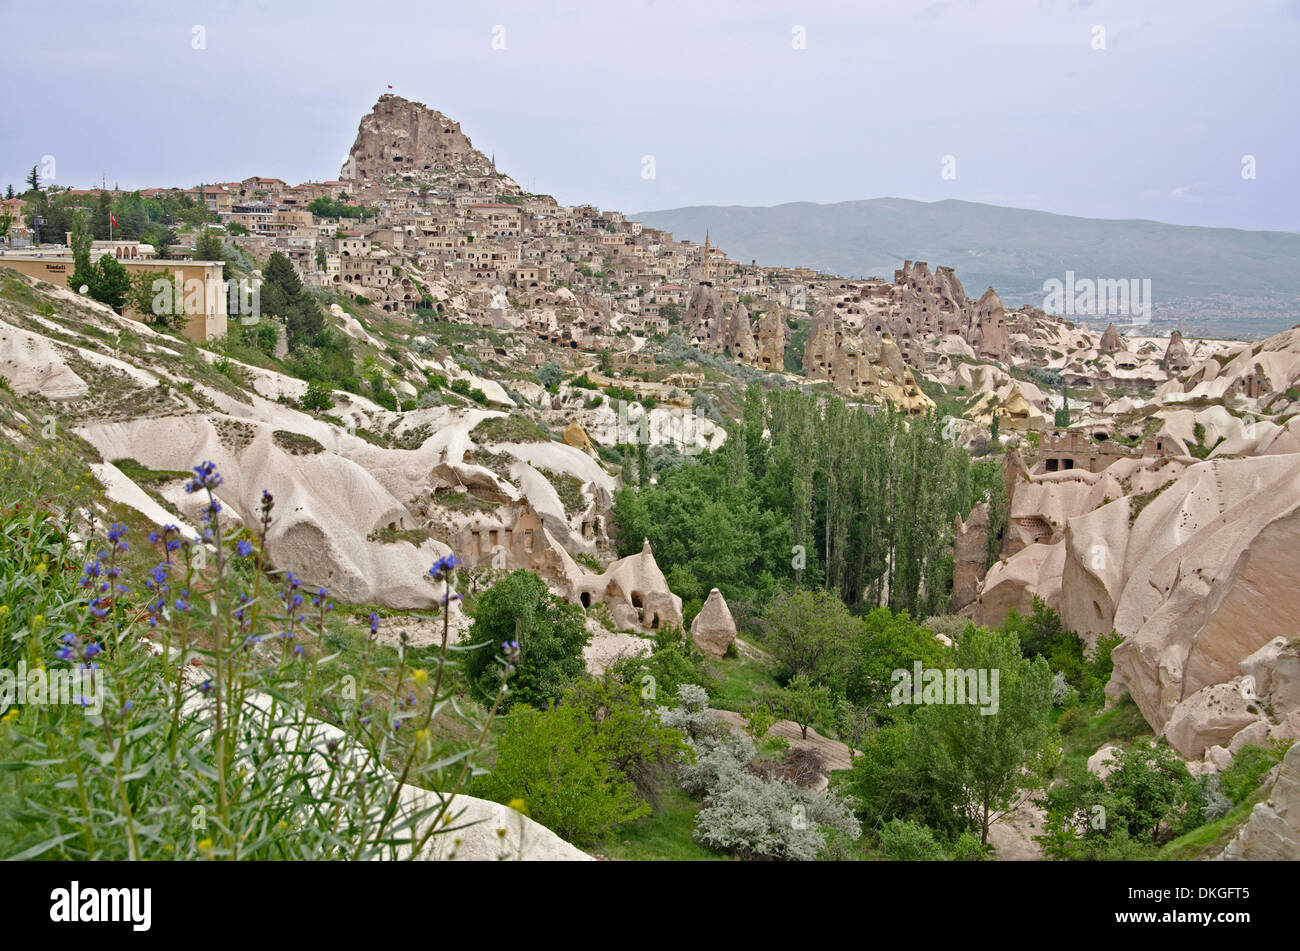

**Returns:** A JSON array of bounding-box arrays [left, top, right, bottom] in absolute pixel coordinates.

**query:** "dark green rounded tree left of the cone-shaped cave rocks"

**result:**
[[465, 569, 590, 707]]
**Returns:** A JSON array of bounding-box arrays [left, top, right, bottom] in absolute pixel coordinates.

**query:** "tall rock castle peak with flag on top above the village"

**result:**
[[342, 95, 506, 185]]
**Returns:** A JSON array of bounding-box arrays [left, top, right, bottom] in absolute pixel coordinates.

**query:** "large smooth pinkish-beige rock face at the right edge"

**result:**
[[1061, 455, 1300, 759]]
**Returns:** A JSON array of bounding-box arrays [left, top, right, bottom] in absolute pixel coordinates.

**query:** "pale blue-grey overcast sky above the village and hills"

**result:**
[[0, 0, 1300, 231]]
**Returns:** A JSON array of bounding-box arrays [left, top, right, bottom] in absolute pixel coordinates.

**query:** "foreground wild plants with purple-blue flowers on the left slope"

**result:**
[[0, 443, 499, 860]]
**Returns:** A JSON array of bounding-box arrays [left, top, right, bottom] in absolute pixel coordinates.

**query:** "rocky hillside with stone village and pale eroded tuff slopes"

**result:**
[[0, 95, 1300, 859]]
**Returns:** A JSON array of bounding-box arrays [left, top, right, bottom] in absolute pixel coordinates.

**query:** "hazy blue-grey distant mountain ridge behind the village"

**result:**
[[631, 197, 1300, 322]]
